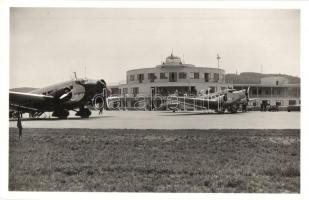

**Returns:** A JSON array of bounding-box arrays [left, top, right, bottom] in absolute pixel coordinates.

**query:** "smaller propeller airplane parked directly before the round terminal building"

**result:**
[[167, 88, 251, 113]]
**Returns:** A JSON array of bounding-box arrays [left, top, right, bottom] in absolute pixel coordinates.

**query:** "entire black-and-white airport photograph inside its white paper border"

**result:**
[[8, 7, 302, 194]]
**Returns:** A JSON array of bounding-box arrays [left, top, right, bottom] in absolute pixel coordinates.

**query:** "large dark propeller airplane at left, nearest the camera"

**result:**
[[9, 75, 106, 119]]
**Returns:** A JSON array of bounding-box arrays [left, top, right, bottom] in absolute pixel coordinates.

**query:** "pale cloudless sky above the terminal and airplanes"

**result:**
[[10, 8, 300, 88]]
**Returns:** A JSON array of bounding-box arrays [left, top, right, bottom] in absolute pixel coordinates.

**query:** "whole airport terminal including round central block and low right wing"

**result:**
[[108, 53, 300, 108]]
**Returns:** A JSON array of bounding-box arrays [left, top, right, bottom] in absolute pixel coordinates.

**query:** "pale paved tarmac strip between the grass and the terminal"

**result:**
[[9, 111, 300, 129]]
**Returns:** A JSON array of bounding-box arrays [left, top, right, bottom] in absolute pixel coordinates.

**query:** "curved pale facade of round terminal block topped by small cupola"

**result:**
[[111, 54, 228, 96]]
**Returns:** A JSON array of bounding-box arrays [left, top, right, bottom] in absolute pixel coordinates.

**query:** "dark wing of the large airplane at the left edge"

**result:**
[[9, 91, 55, 112]]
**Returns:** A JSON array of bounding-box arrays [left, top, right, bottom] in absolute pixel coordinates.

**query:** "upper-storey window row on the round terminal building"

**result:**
[[129, 72, 219, 83]]
